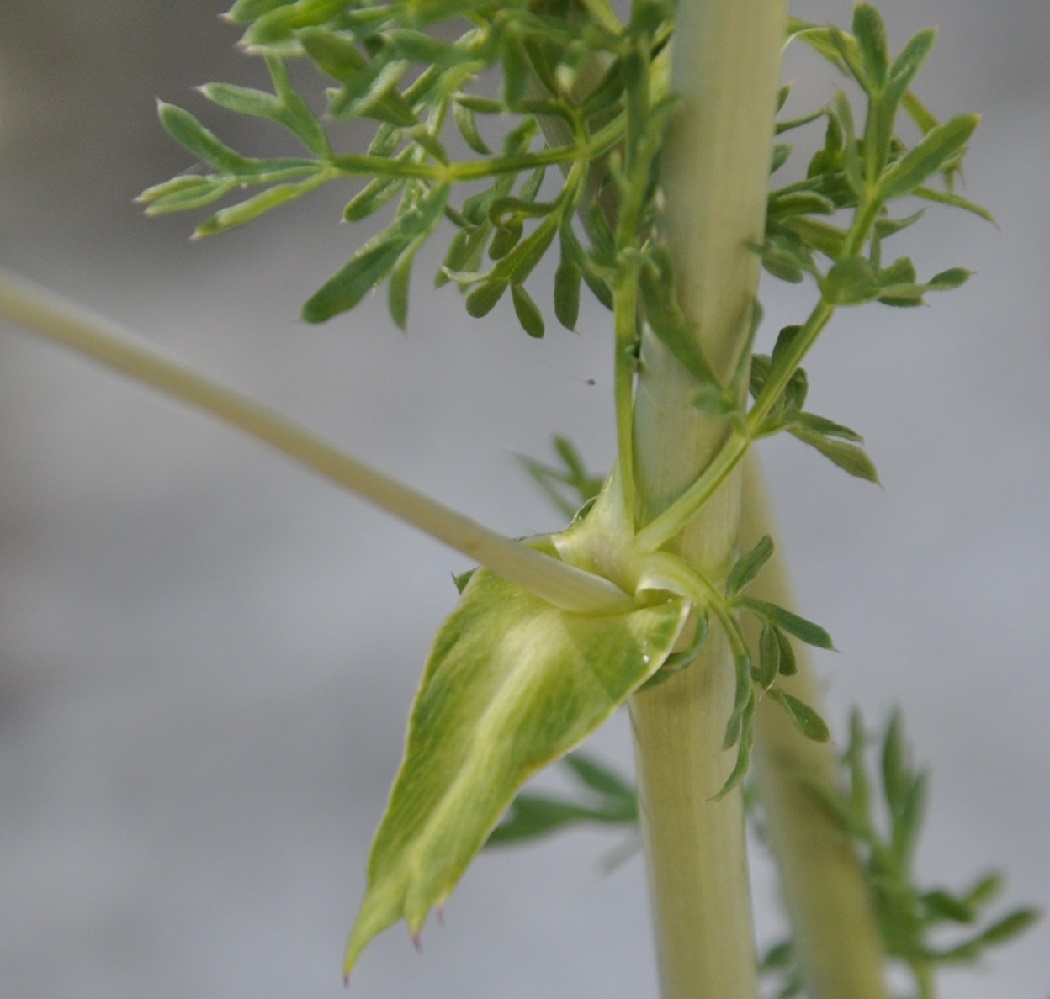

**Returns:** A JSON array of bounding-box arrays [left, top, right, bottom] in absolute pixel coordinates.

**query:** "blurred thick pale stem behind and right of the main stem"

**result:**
[[740, 456, 888, 999]]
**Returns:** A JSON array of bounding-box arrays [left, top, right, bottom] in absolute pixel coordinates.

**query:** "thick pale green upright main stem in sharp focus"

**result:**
[[631, 0, 786, 999]]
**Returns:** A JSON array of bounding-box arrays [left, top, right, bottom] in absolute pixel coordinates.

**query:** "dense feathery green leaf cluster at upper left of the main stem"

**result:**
[[141, 0, 671, 336]]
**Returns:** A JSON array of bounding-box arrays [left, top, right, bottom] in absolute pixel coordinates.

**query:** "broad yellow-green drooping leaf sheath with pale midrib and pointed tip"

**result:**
[[345, 554, 690, 975]]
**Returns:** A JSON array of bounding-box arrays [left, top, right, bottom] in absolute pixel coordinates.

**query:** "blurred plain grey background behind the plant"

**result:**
[[0, 0, 1050, 999]]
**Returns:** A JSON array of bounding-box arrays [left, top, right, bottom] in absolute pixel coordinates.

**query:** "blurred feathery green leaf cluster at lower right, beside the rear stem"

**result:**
[[762, 711, 1038, 999]]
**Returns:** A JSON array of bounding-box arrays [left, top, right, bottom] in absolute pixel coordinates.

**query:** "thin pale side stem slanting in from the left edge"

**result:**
[[0, 263, 631, 613]]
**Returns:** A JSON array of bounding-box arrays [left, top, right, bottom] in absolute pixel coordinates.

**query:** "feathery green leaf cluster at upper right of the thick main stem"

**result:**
[[726, 3, 991, 482]]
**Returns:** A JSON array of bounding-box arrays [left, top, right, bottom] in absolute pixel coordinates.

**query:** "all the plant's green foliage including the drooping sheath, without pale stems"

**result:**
[[133, 0, 1027, 983]]
